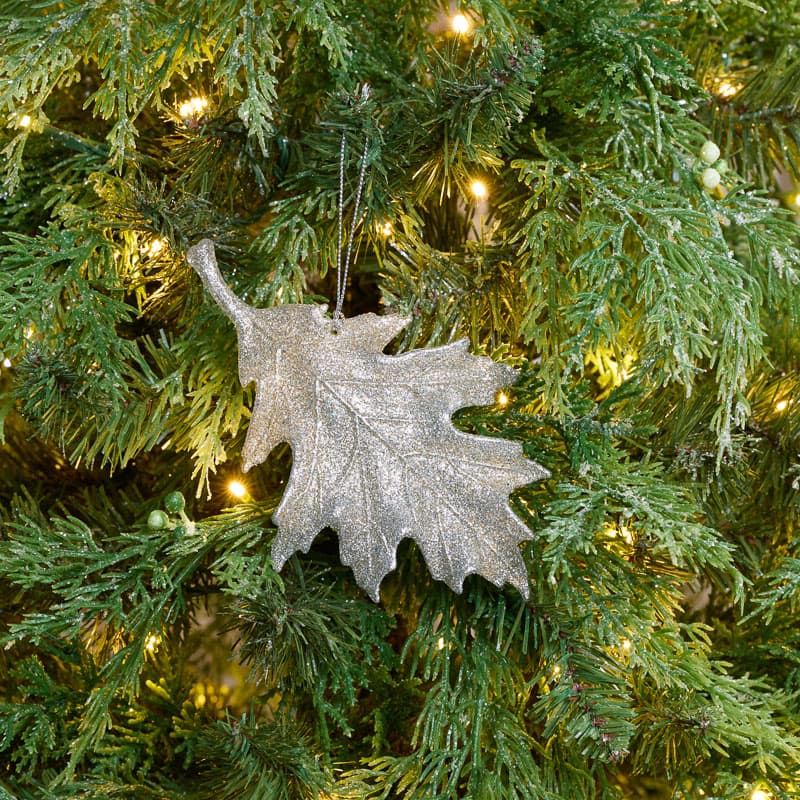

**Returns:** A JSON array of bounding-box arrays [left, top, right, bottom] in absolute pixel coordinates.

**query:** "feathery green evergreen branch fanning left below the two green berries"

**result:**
[[0, 500, 282, 775]]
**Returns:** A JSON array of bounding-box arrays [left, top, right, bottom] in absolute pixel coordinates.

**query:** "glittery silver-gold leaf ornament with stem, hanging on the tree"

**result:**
[[187, 239, 549, 601]]
